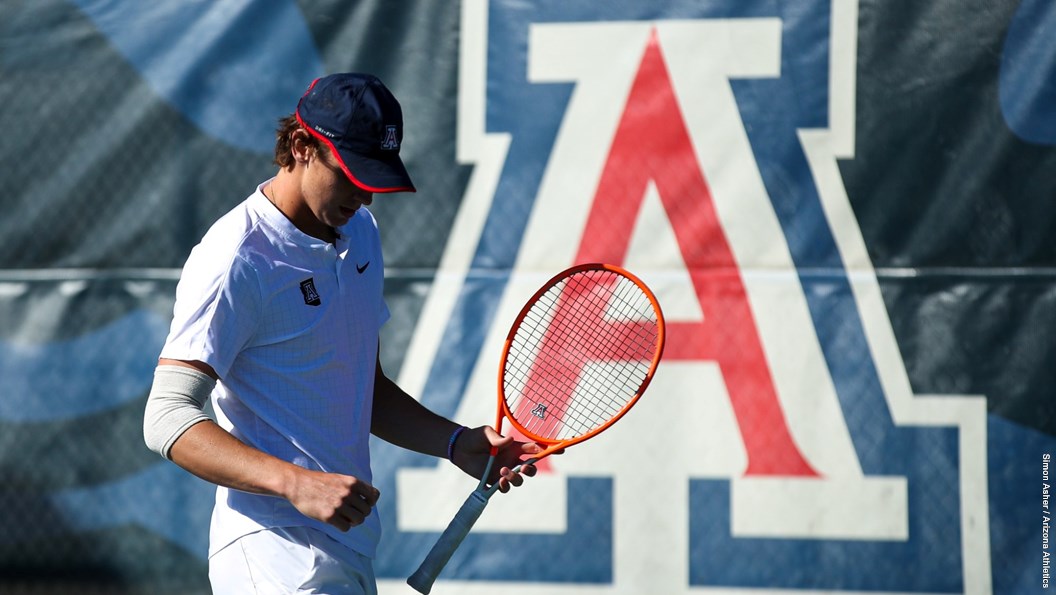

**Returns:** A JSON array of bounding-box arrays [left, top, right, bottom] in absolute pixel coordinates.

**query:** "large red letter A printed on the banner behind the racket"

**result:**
[[576, 32, 817, 477]]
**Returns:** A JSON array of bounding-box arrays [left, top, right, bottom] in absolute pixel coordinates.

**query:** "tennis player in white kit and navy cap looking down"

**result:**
[[144, 74, 542, 594]]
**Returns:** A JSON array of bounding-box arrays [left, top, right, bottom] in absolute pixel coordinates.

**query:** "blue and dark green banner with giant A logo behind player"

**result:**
[[0, 0, 1056, 594]]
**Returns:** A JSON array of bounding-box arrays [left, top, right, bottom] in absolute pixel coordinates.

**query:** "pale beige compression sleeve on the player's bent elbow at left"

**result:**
[[143, 366, 216, 459]]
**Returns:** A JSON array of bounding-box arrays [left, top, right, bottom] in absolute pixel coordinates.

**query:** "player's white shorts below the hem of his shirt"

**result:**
[[209, 527, 378, 595]]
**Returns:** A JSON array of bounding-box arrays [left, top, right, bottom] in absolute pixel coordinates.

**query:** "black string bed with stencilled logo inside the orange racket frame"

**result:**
[[504, 269, 659, 440]]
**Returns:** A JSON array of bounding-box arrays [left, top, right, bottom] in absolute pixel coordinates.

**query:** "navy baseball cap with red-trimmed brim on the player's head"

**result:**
[[296, 73, 415, 192]]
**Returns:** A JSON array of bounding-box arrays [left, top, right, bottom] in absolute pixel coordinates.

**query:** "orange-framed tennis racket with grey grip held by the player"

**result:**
[[407, 264, 664, 594]]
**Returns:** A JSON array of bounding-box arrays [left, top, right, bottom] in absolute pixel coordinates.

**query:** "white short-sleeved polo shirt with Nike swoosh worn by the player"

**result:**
[[162, 183, 389, 557]]
